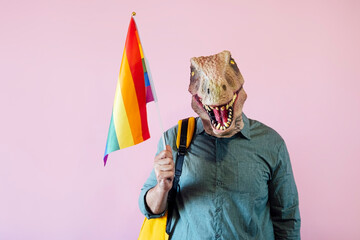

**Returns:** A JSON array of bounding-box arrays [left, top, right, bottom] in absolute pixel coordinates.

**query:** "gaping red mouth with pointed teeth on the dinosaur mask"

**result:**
[[195, 90, 240, 131]]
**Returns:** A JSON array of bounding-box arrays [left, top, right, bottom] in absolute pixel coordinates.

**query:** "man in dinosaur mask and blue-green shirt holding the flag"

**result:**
[[139, 51, 300, 240]]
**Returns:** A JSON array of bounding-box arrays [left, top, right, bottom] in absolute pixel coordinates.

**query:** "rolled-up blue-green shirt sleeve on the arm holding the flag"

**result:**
[[139, 139, 165, 219]]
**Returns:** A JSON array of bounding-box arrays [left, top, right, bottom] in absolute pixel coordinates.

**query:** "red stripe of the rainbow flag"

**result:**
[[125, 18, 150, 141]]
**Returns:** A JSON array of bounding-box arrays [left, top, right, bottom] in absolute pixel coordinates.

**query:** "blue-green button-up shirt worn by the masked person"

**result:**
[[139, 114, 301, 240]]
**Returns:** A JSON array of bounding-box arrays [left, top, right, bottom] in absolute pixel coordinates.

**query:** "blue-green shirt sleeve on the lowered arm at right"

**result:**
[[269, 142, 301, 240]]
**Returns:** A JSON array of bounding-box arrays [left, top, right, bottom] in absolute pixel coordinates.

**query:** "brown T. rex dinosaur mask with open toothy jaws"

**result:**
[[189, 51, 247, 137]]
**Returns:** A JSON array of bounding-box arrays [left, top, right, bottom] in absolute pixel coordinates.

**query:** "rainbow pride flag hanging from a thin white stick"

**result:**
[[104, 16, 156, 166]]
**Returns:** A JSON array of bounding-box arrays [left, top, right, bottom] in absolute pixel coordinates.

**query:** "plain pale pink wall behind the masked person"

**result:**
[[0, 0, 360, 240]]
